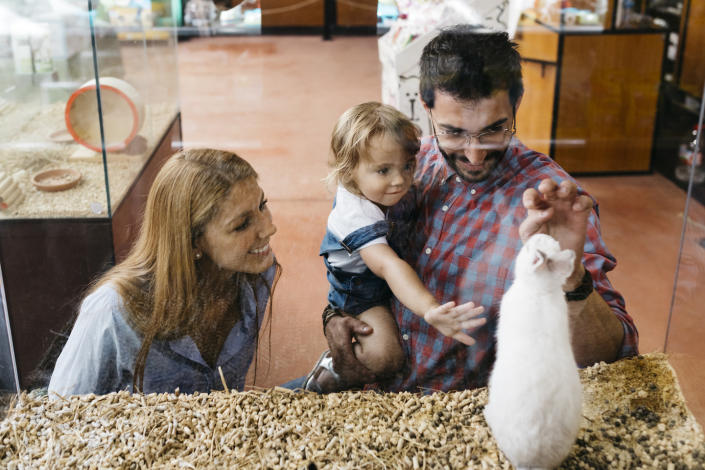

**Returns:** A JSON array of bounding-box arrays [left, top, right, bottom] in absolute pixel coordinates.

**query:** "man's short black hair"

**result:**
[[419, 25, 524, 109]]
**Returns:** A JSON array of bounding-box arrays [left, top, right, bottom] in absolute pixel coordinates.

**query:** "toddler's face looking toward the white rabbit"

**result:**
[[354, 131, 416, 207]]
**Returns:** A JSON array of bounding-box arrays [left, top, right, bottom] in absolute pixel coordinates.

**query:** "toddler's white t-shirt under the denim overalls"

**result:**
[[328, 186, 388, 273]]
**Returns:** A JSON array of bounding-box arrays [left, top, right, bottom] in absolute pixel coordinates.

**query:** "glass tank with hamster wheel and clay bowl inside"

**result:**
[[0, 0, 178, 219]]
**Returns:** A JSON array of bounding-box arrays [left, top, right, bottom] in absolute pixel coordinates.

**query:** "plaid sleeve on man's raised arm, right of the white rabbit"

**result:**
[[583, 205, 639, 359]]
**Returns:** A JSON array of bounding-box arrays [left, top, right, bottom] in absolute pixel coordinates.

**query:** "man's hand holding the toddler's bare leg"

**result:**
[[324, 315, 376, 386]]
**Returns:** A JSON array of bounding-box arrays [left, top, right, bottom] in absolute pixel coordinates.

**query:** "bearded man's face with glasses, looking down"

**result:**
[[431, 90, 514, 182]]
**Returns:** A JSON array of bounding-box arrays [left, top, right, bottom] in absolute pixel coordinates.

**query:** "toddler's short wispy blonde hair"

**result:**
[[326, 101, 421, 195]]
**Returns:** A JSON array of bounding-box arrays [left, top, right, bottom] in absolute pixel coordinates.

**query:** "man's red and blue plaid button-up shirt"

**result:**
[[383, 138, 638, 391]]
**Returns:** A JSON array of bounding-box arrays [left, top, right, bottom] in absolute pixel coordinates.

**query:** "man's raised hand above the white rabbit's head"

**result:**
[[519, 179, 592, 291]]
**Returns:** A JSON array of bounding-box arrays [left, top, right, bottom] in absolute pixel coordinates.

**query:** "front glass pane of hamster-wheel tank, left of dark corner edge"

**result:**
[[0, 0, 107, 219]]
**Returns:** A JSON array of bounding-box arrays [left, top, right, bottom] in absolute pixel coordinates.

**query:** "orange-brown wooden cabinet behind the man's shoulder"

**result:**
[[515, 20, 665, 174]]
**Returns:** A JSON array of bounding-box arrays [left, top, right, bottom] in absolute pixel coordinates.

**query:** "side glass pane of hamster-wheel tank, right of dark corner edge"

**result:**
[[95, 0, 178, 212]]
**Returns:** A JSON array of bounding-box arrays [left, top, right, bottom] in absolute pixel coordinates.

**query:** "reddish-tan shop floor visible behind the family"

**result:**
[[179, 36, 705, 424]]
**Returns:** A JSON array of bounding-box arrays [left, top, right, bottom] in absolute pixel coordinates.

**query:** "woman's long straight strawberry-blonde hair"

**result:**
[[93, 149, 281, 391]]
